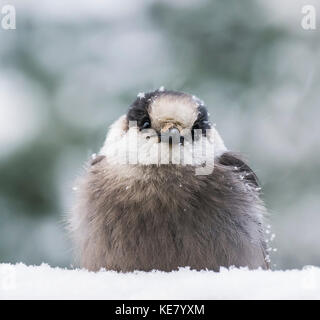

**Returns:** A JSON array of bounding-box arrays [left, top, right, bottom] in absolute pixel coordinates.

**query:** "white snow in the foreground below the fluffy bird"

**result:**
[[0, 264, 320, 300]]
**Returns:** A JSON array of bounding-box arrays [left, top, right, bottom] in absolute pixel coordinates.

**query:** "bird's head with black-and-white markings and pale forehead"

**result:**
[[101, 89, 226, 170]]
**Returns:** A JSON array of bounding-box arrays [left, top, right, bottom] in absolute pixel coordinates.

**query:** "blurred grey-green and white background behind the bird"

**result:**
[[0, 0, 320, 269]]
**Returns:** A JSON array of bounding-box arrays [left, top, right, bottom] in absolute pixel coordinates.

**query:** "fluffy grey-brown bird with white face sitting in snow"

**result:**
[[69, 88, 269, 272]]
